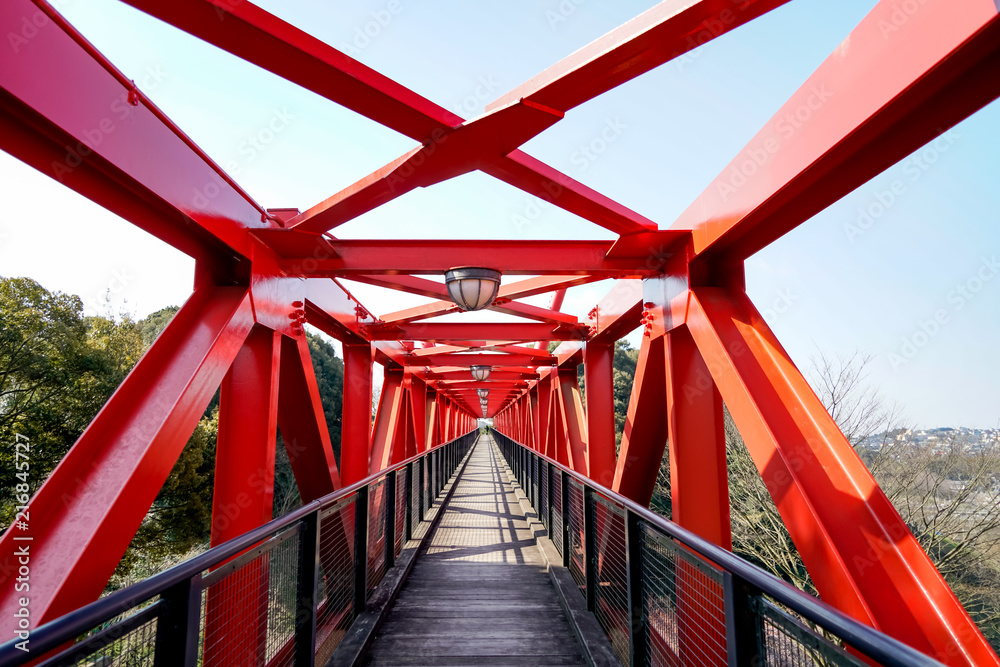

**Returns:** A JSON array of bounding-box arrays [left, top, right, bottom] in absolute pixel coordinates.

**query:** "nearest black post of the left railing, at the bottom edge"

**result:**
[[153, 575, 201, 667]]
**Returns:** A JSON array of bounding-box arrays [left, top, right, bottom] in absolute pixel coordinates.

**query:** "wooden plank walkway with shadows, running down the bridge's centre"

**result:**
[[365, 436, 586, 666]]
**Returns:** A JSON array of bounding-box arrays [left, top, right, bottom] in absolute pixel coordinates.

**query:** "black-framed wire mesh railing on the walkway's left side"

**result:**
[[0, 431, 478, 667]]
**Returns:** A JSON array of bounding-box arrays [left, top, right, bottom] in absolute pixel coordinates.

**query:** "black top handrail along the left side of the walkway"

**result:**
[[0, 431, 476, 667]]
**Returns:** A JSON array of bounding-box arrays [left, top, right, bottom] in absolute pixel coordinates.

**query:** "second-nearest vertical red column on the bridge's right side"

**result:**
[[583, 342, 615, 488]]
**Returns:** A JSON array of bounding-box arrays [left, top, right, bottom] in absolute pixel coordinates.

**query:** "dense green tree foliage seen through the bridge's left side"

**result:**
[[0, 278, 344, 589]]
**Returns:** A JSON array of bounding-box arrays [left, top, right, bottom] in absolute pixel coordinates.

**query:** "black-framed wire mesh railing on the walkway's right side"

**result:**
[[491, 430, 941, 667]]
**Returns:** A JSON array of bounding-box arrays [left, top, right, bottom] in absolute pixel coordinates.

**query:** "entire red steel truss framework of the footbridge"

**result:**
[[0, 0, 1000, 665]]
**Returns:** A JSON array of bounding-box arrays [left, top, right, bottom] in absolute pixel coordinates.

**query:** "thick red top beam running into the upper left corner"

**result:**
[[0, 0, 277, 258]]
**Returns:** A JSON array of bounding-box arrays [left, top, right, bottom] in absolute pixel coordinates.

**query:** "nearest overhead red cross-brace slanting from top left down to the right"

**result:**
[[126, 0, 668, 240]]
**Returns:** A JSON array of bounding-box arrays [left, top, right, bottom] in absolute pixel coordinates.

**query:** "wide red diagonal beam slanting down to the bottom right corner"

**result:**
[[688, 288, 1000, 667]]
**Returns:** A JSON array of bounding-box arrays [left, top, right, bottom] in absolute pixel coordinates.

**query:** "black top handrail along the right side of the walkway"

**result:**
[[491, 429, 942, 667]]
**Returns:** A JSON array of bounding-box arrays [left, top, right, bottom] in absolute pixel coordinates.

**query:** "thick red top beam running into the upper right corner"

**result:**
[[672, 0, 1000, 260]]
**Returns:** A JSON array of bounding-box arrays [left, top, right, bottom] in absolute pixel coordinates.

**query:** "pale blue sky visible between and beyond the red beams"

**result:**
[[0, 0, 1000, 427]]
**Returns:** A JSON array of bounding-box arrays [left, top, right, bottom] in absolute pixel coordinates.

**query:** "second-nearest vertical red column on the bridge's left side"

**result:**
[[340, 343, 372, 486]]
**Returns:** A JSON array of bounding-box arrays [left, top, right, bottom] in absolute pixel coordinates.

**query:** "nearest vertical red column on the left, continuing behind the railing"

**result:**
[[204, 326, 281, 667]]
